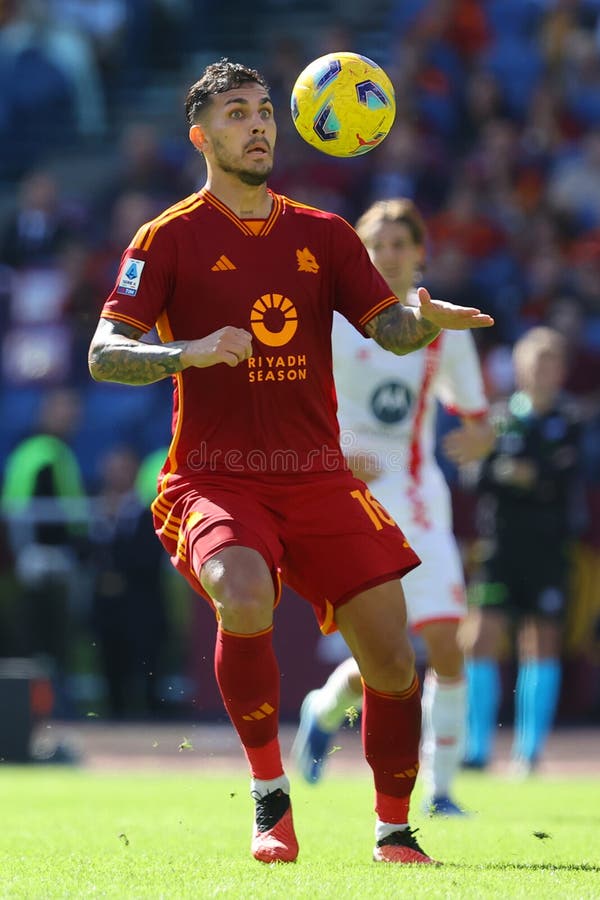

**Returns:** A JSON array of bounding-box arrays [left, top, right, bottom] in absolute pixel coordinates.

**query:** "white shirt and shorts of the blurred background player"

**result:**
[[332, 298, 488, 625]]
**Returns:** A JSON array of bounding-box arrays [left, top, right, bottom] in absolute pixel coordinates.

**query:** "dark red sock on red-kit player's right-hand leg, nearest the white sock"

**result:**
[[362, 675, 421, 825]]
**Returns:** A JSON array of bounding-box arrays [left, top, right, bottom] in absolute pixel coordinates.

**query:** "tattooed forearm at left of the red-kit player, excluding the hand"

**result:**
[[89, 319, 186, 384]]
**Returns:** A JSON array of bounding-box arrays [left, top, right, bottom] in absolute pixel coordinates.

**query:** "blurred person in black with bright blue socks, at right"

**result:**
[[463, 327, 581, 773]]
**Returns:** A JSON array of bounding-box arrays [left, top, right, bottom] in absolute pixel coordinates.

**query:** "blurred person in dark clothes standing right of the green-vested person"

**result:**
[[91, 448, 167, 719]]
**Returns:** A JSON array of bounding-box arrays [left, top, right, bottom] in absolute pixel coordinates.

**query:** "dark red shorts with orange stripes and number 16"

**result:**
[[152, 471, 420, 633]]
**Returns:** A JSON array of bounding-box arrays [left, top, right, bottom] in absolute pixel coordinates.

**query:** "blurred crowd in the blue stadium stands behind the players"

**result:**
[[0, 0, 600, 717]]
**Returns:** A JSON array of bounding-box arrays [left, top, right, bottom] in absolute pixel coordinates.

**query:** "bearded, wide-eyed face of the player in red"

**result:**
[[190, 83, 277, 185]]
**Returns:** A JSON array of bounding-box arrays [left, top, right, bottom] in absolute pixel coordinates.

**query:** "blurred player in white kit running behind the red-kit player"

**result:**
[[293, 198, 494, 816]]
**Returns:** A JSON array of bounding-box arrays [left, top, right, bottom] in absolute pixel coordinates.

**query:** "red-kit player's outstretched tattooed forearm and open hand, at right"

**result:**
[[364, 287, 494, 356]]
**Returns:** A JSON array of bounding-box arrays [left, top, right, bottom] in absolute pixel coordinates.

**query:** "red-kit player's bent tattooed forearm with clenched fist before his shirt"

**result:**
[[88, 318, 252, 384]]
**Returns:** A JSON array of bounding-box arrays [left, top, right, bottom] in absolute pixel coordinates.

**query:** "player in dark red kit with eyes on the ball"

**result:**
[[90, 60, 492, 863]]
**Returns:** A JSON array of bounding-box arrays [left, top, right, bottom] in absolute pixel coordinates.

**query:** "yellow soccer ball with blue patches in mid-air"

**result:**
[[291, 53, 396, 157]]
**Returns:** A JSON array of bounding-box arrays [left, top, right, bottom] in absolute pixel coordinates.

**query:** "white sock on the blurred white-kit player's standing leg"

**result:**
[[421, 669, 467, 797]]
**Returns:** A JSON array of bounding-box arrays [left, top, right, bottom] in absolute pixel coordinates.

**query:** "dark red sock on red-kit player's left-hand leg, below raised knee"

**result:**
[[215, 627, 283, 780]]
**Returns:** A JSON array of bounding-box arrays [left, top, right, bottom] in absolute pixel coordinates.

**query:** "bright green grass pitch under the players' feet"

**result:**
[[0, 765, 600, 900]]
